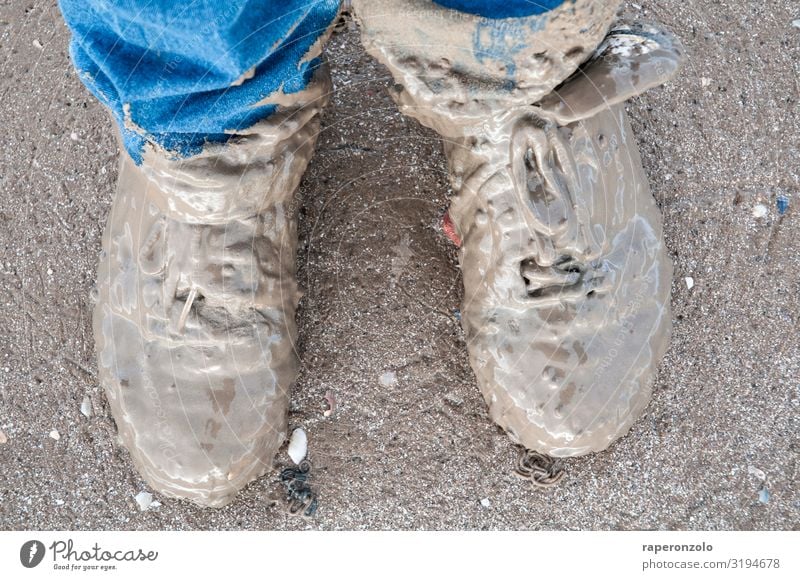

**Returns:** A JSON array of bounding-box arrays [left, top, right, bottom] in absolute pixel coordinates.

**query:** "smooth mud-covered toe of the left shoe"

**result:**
[[98, 307, 294, 506]]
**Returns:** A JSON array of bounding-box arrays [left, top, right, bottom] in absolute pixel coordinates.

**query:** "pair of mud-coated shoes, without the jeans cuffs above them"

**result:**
[[94, 10, 679, 507]]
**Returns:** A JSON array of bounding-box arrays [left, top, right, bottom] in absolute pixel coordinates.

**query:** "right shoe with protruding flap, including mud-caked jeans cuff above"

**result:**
[[356, 0, 680, 457]]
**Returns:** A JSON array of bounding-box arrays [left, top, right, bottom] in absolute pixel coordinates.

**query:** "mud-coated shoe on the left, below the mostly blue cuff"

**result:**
[[94, 71, 330, 506]]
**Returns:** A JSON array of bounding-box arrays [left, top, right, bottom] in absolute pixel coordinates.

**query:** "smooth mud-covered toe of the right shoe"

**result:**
[[469, 213, 671, 457]]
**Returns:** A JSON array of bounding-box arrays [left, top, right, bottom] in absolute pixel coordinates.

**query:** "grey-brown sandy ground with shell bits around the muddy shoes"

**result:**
[[0, 0, 800, 529]]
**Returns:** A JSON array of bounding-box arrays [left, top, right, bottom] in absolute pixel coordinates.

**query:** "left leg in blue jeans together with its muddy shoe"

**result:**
[[62, 0, 338, 506]]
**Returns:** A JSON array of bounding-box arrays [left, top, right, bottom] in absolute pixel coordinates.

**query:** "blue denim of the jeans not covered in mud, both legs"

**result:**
[[60, 0, 563, 164]]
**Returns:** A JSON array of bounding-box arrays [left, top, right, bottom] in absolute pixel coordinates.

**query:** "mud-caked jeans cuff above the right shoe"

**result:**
[[353, 0, 620, 109]]
